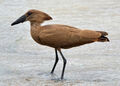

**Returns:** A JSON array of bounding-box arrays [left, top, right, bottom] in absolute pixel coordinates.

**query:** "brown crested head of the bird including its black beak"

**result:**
[[11, 9, 52, 26]]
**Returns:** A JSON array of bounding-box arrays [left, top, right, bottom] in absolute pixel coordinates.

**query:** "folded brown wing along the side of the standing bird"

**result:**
[[39, 25, 101, 48]]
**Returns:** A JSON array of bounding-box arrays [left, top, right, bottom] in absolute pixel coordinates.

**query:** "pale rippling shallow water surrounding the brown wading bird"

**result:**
[[0, 0, 120, 86]]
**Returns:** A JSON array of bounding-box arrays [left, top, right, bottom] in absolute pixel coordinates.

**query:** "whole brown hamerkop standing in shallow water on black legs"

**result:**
[[11, 9, 109, 79]]
